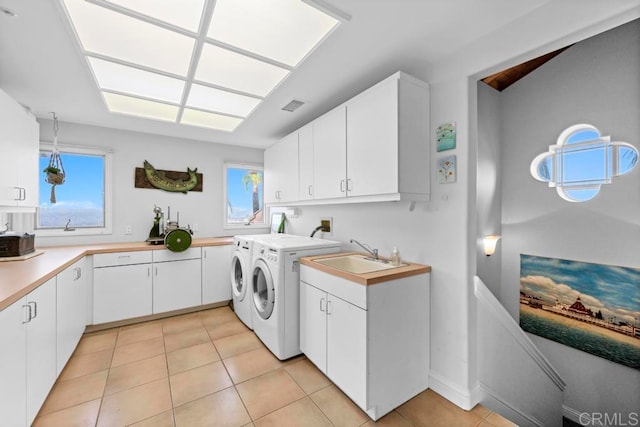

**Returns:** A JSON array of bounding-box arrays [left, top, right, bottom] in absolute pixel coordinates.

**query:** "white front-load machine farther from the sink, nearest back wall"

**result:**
[[231, 234, 298, 329]]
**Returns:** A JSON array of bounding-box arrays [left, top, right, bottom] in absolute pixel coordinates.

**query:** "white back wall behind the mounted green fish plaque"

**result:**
[[36, 120, 264, 246]]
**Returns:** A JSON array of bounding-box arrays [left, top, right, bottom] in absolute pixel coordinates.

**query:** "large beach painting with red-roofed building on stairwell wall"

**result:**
[[520, 255, 640, 369]]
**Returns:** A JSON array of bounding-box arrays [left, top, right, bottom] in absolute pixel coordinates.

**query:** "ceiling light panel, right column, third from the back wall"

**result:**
[[195, 43, 289, 96]]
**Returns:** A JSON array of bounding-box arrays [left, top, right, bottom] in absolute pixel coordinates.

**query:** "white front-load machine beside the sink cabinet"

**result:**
[[251, 237, 341, 360]]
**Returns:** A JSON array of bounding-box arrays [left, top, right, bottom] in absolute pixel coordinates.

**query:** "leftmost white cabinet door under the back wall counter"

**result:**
[[93, 264, 153, 324]]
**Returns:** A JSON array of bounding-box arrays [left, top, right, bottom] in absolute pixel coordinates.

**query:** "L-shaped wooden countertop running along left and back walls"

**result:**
[[0, 237, 233, 310]]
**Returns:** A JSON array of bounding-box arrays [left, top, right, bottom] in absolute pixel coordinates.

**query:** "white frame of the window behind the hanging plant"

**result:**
[[34, 141, 113, 237]]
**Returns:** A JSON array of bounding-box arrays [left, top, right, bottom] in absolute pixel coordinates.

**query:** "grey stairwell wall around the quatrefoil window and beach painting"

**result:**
[[501, 20, 640, 414]]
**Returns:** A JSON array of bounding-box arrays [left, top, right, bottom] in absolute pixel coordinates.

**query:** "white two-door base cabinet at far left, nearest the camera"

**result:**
[[0, 278, 56, 426]]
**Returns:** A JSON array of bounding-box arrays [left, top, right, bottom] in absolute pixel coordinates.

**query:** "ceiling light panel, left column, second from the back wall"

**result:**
[[88, 58, 184, 104]]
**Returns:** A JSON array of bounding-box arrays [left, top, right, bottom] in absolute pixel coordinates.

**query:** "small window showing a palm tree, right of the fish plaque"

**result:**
[[224, 163, 265, 228]]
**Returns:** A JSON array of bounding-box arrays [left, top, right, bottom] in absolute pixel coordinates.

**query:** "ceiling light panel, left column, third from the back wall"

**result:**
[[64, 0, 195, 76]]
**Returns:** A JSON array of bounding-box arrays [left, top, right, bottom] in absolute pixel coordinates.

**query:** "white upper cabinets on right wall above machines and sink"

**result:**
[[265, 72, 431, 204]]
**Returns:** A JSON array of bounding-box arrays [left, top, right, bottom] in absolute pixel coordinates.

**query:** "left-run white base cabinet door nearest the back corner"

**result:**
[[56, 259, 87, 375]]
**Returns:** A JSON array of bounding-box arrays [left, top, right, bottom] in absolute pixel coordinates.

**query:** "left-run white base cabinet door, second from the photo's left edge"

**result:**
[[26, 278, 57, 425]]
